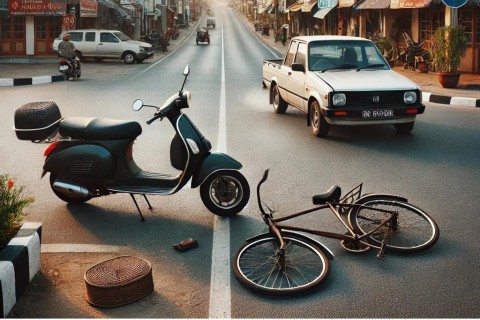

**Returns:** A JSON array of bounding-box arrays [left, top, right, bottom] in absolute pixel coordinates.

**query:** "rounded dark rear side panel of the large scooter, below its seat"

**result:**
[[43, 144, 116, 178]]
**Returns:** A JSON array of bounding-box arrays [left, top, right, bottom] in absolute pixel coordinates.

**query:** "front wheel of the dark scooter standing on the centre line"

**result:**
[[200, 171, 250, 217]]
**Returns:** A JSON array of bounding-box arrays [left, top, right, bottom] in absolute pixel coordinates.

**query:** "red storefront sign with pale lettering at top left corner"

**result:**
[[9, 0, 67, 16]]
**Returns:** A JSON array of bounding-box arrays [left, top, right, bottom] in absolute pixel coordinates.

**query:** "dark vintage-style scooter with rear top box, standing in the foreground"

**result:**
[[15, 65, 250, 221]]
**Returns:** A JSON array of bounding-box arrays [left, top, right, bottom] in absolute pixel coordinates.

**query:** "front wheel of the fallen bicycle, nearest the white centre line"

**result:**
[[233, 234, 330, 295]]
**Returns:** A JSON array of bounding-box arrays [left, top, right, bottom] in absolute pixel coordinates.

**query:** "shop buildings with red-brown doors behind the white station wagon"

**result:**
[[0, 0, 193, 58]]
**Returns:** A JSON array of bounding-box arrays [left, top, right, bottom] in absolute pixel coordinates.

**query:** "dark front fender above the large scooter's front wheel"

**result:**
[[191, 152, 242, 188]]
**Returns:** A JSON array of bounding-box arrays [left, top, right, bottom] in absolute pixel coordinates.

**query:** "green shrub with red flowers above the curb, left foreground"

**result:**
[[0, 174, 33, 248]]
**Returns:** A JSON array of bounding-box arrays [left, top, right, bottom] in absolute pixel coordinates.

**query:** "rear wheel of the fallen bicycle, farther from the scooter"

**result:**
[[348, 197, 440, 253]]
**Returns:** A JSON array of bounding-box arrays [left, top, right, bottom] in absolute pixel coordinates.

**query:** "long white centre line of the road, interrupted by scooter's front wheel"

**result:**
[[208, 20, 232, 319]]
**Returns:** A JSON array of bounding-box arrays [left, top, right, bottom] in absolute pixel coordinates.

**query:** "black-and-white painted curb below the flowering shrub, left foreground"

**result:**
[[0, 222, 42, 318]]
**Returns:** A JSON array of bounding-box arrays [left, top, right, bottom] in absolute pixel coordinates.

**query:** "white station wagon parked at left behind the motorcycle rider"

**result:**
[[53, 29, 153, 64]]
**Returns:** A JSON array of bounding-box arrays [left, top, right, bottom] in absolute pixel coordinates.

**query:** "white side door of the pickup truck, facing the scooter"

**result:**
[[288, 42, 308, 111]]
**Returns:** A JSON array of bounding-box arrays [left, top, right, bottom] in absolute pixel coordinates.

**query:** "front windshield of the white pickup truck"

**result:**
[[308, 40, 390, 72]]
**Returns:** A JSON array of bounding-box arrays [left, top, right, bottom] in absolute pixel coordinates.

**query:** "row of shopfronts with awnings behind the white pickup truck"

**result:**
[[251, 0, 480, 73]]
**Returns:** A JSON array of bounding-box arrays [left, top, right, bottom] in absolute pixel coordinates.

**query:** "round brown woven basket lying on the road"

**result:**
[[84, 256, 153, 307]]
